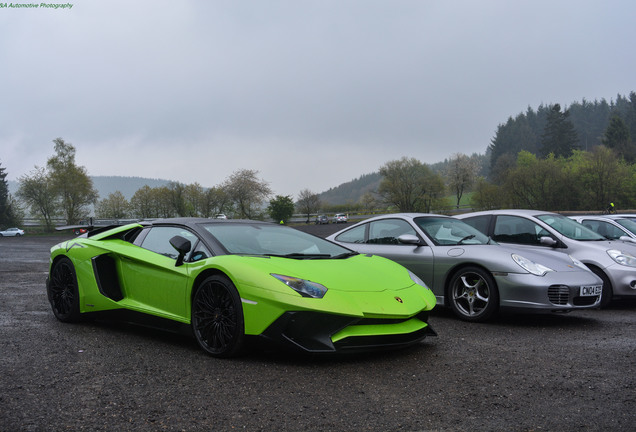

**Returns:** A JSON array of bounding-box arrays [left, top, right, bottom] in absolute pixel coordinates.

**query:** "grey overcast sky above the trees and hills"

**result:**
[[0, 0, 636, 198]]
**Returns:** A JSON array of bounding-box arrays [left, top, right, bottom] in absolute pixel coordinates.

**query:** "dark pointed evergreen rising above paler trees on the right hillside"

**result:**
[[541, 104, 578, 157]]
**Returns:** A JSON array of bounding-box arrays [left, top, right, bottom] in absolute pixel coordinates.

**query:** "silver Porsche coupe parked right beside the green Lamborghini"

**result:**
[[327, 213, 602, 321]]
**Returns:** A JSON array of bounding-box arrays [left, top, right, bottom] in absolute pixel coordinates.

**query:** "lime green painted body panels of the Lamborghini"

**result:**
[[50, 224, 435, 342]]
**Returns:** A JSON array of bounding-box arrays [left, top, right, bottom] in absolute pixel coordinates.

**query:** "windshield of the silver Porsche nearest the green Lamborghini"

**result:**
[[415, 217, 494, 246]]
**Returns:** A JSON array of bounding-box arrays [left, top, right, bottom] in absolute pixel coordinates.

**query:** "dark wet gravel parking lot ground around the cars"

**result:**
[[0, 225, 636, 432]]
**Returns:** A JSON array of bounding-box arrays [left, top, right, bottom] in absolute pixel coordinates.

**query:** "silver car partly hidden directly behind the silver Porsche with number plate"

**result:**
[[456, 210, 636, 307]]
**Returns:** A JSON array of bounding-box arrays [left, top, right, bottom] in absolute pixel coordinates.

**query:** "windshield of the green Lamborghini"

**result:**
[[203, 223, 353, 259]]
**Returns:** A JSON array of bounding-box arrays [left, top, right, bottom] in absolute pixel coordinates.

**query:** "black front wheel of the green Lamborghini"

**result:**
[[192, 275, 245, 357]]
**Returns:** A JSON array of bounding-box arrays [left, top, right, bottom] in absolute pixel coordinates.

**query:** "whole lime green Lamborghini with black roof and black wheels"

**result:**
[[47, 218, 435, 357]]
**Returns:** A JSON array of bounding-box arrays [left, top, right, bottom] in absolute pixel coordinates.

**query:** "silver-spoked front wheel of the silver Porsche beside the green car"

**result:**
[[448, 267, 499, 322]]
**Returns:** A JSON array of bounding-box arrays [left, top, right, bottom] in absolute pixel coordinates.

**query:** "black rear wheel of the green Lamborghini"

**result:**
[[47, 257, 80, 322]]
